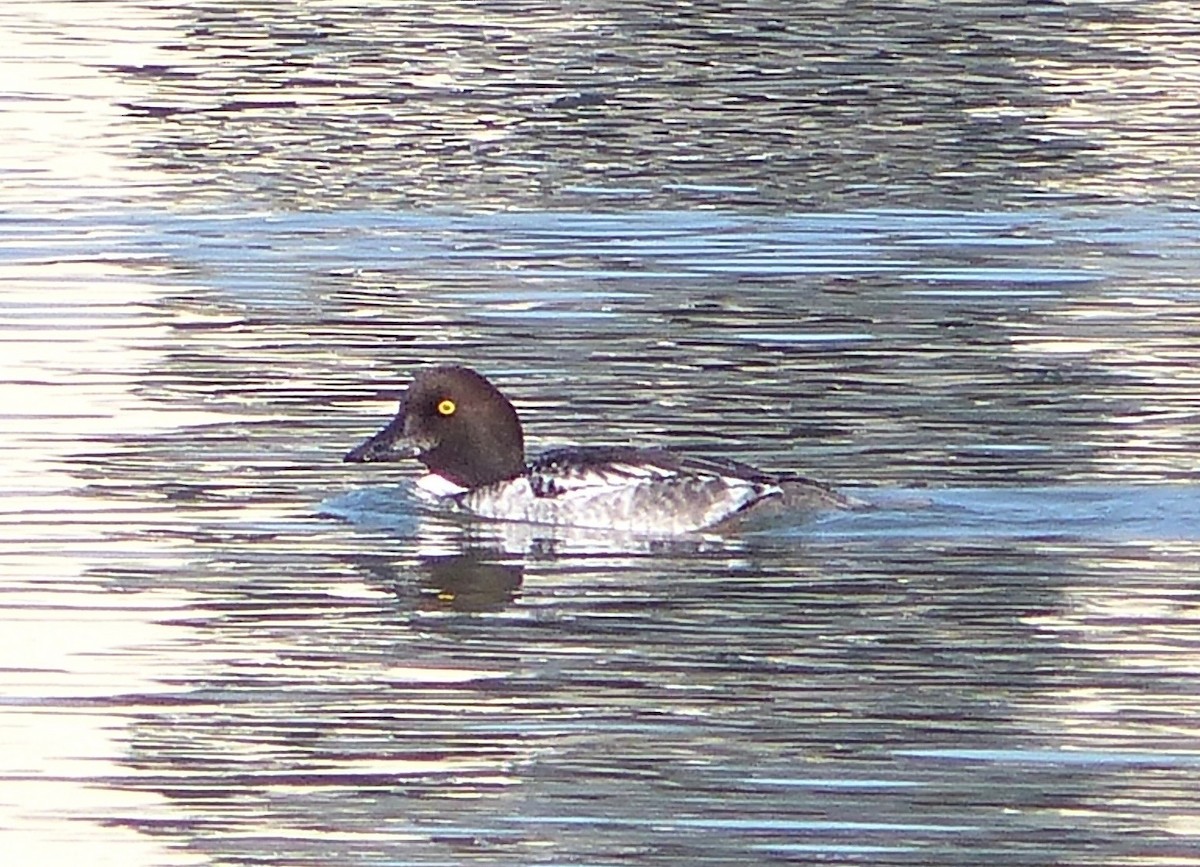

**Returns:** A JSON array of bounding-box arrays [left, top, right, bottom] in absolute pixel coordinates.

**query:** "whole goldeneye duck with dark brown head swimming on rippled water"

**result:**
[[344, 365, 858, 536]]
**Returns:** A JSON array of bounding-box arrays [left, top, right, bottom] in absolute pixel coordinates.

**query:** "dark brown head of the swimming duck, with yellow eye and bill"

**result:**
[[344, 365, 524, 488]]
